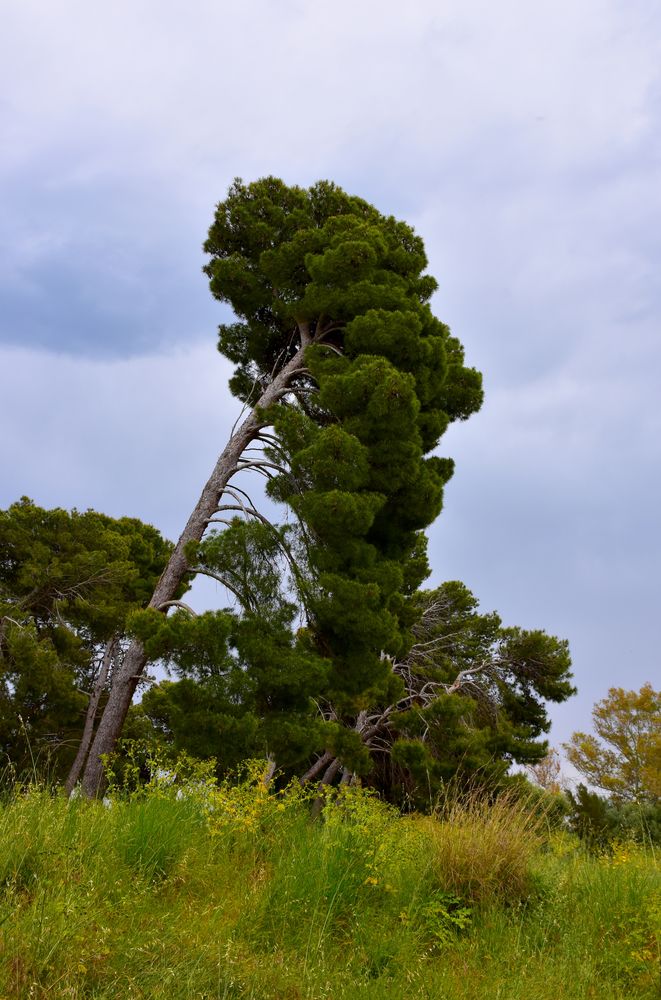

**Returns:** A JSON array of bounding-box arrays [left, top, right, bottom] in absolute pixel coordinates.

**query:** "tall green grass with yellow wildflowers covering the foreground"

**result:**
[[0, 774, 661, 1000]]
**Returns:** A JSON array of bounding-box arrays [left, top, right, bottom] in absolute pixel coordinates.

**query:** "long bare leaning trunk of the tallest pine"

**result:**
[[82, 348, 307, 798]]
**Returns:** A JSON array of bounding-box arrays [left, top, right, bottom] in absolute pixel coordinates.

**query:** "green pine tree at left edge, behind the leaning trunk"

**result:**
[[0, 497, 171, 776]]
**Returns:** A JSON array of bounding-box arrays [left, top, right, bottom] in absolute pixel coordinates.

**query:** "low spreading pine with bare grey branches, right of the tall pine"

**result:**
[[300, 581, 575, 806]]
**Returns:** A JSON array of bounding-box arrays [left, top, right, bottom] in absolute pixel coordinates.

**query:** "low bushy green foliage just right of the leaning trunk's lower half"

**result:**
[[127, 519, 329, 775]]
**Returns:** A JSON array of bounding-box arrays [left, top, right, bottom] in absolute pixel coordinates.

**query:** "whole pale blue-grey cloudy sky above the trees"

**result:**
[[0, 0, 661, 756]]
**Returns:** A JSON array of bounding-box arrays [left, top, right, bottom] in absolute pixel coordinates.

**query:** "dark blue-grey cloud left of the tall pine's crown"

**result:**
[[0, 172, 227, 357]]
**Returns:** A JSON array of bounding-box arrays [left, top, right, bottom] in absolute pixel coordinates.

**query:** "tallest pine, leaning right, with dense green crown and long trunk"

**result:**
[[83, 178, 482, 794]]
